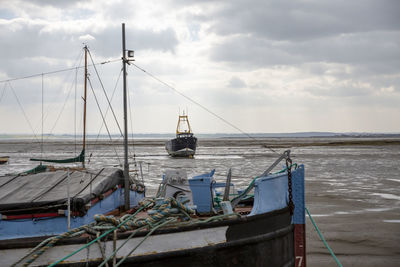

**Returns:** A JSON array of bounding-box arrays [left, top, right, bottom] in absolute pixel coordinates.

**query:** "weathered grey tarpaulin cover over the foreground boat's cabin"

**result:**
[[0, 168, 124, 213]]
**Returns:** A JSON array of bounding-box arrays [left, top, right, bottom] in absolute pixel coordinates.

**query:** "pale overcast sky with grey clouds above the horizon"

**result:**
[[0, 0, 400, 134]]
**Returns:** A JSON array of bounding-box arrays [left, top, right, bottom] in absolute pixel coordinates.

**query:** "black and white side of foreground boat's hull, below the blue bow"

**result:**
[[0, 208, 295, 266]]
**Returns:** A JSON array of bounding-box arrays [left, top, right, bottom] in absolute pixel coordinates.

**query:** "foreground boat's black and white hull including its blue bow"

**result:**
[[0, 165, 305, 267]]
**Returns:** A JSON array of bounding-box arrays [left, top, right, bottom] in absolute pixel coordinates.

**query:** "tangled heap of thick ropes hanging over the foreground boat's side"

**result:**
[[12, 197, 234, 267]]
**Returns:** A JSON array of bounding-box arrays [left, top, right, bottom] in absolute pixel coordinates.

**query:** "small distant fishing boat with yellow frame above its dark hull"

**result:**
[[165, 113, 197, 158]]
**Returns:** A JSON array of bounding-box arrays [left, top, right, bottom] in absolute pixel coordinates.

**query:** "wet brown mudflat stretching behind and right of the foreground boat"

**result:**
[[0, 138, 400, 266]]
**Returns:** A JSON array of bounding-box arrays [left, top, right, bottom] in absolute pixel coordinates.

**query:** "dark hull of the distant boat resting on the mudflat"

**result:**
[[165, 136, 197, 157]]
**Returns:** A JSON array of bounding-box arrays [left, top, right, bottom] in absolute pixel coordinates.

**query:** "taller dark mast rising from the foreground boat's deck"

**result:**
[[122, 23, 130, 210]]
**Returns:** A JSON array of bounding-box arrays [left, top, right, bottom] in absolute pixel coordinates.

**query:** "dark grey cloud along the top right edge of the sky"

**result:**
[[196, 0, 400, 41]]
